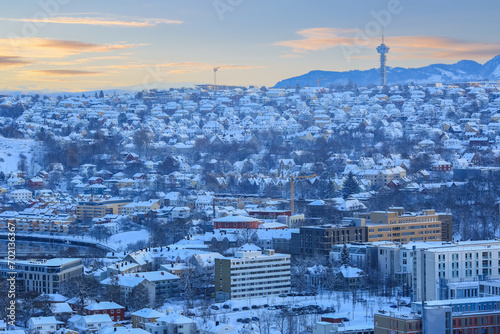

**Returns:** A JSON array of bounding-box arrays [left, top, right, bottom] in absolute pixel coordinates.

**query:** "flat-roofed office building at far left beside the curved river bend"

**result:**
[[0, 258, 83, 293]]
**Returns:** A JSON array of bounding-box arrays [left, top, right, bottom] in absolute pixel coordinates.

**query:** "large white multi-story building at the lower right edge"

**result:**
[[371, 240, 500, 301]]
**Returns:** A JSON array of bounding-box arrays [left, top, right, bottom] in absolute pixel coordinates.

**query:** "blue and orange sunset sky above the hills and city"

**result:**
[[0, 0, 500, 92]]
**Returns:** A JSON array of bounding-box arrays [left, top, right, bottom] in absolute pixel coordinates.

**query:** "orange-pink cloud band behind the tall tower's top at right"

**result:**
[[274, 28, 500, 59]]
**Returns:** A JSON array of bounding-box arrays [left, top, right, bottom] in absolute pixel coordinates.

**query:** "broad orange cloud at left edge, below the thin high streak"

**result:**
[[0, 37, 144, 58]]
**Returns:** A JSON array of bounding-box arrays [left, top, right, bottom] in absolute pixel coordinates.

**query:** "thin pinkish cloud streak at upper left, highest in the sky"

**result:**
[[0, 16, 183, 28]]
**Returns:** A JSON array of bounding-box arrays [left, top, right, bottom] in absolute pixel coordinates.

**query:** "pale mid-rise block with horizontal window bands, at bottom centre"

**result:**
[[215, 244, 290, 300]]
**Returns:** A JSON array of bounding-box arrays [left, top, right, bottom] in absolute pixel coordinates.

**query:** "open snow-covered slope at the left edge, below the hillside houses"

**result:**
[[0, 136, 38, 174]]
